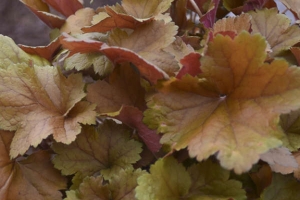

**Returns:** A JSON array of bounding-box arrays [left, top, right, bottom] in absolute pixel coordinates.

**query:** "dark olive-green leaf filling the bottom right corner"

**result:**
[[260, 173, 300, 200]]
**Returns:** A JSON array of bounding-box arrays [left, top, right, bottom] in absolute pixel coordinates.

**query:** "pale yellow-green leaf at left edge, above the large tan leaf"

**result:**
[[0, 34, 49, 69]]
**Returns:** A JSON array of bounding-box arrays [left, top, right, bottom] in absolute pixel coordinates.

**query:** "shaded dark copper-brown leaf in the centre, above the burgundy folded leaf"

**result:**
[[87, 64, 145, 114]]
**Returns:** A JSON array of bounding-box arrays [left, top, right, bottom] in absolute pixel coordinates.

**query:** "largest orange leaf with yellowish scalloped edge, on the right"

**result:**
[[144, 32, 300, 173]]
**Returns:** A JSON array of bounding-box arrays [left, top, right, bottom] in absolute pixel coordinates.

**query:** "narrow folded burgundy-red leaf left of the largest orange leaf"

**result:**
[[108, 106, 162, 153]]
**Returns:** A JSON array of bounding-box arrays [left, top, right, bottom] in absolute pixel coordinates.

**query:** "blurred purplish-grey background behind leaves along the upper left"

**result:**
[[0, 0, 120, 46]]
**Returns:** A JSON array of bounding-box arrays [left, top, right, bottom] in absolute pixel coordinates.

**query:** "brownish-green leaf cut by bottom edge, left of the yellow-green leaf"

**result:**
[[66, 168, 145, 200]]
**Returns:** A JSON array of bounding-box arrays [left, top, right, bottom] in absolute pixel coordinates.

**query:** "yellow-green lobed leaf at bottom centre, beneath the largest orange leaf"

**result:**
[[136, 157, 246, 200]]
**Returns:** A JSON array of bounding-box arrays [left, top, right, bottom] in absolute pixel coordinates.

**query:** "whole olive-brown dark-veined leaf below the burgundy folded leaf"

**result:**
[[53, 121, 142, 179]]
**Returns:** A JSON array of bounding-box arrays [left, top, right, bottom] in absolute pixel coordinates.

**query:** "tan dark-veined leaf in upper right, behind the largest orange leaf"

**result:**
[[249, 9, 300, 56]]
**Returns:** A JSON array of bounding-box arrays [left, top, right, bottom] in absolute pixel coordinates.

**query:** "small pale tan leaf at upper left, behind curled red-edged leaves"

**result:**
[[60, 8, 95, 34]]
